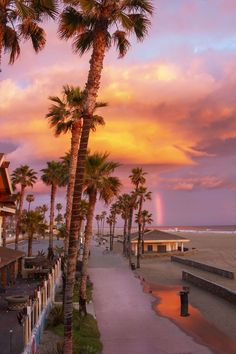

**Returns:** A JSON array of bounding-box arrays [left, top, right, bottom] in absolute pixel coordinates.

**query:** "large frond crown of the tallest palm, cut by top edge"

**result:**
[[59, 0, 153, 57]]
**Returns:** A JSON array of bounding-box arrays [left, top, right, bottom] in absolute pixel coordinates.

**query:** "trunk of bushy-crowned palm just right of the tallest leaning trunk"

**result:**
[[79, 192, 97, 316]]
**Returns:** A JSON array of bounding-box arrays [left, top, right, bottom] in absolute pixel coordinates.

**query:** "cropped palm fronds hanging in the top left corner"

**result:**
[[0, 0, 57, 71]]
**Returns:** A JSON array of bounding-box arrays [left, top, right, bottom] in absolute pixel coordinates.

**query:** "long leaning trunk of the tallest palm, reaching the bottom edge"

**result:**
[[64, 28, 106, 354]]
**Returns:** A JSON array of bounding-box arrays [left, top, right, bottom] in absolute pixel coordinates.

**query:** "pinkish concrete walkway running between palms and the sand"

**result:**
[[89, 244, 213, 354]]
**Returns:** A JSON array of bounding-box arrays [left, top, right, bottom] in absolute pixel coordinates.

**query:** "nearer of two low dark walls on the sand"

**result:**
[[182, 271, 236, 305]]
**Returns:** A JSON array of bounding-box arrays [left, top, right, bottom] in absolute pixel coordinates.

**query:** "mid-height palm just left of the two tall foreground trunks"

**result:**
[[41, 161, 66, 258]]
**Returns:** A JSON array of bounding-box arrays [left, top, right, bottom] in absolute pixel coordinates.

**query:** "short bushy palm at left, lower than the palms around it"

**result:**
[[21, 210, 44, 257]]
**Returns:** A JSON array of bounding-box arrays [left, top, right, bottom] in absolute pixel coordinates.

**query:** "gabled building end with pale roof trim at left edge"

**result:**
[[0, 153, 15, 246]]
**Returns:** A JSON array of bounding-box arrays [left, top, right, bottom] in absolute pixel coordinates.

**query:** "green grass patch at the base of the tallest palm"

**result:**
[[48, 309, 102, 354]]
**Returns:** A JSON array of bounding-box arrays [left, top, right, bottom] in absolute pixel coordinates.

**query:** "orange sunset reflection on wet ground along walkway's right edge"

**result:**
[[144, 283, 236, 354]]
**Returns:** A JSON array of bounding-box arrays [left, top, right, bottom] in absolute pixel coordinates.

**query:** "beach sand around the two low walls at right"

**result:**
[[113, 232, 236, 340]]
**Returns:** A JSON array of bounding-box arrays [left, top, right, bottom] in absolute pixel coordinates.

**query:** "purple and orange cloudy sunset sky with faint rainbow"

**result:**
[[0, 0, 236, 225]]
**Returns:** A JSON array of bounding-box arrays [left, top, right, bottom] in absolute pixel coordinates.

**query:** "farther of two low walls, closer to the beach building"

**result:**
[[171, 256, 234, 279]]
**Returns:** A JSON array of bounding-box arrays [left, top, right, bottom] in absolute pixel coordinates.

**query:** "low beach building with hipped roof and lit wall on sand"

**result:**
[[131, 230, 189, 255]]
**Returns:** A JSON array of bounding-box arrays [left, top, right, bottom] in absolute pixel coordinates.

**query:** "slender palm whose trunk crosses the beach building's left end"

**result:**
[[136, 186, 151, 268]]
